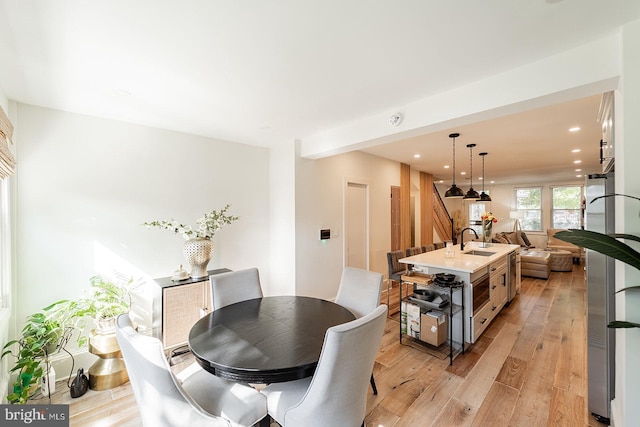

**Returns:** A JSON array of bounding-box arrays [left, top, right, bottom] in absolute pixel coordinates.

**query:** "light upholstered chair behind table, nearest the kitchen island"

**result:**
[[336, 267, 382, 394]]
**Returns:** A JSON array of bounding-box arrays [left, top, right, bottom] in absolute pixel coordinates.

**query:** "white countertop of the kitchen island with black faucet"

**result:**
[[398, 242, 520, 273]]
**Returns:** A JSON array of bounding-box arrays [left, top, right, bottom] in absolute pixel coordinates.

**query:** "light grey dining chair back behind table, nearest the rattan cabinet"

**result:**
[[209, 268, 262, 310]]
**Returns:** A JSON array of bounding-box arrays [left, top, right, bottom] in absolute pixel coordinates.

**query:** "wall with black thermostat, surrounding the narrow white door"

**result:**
[[296, 152, 400, 299]]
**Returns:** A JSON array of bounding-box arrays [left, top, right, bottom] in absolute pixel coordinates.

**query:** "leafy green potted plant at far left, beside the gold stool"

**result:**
[[1, 309, 65, 404]]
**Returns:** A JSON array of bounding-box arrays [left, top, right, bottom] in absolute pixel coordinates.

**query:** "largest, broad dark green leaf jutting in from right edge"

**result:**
[[554, 229, 640, 270]]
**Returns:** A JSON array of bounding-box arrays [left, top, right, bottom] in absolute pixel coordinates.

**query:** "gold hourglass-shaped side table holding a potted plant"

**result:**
[[89, 333, 129, 391]]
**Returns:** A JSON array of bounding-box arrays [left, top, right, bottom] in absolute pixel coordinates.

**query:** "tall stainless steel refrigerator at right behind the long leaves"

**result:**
[[585, 172, 615, 423]]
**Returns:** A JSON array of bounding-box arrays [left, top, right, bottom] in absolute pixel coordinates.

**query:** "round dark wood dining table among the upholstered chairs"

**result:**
[[189, 296, 355, 384]]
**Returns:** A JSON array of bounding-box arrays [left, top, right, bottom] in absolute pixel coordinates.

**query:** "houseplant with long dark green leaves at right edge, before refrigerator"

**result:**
[[555, 194, 640, 328]]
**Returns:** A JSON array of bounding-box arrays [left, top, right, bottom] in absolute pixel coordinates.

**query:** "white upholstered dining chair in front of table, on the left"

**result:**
[[116, 314, 268, 427]]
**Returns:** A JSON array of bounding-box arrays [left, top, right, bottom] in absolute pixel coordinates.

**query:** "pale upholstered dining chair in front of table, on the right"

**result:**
[[262, 305, 387, 427]]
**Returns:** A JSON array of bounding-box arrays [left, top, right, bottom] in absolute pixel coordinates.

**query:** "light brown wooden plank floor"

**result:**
[[43, 266, 603, 427]]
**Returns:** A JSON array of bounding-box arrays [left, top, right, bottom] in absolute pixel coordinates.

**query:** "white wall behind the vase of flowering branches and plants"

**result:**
[[14, 105, 269, 328]]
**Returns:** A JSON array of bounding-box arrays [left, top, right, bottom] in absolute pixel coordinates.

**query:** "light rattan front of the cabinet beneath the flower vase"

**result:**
[[162, 280, 209, 349]]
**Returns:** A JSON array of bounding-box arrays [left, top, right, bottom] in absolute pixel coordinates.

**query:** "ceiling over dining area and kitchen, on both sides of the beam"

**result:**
[[0, 0, 640, 187]]
